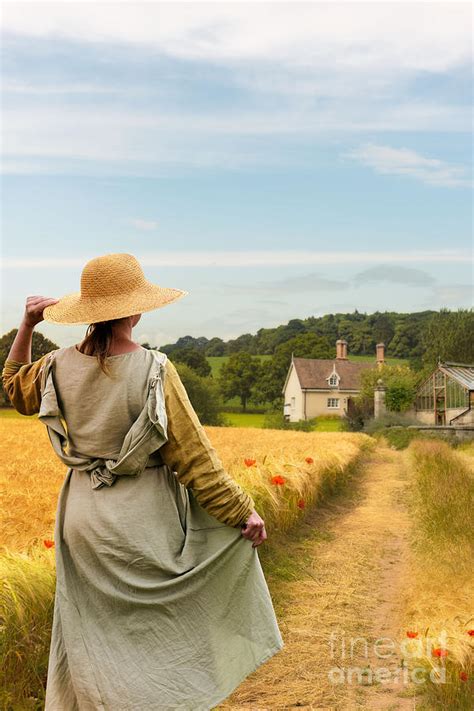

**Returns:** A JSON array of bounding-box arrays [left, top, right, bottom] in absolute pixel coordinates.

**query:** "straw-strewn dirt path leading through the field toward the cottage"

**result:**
[[218, 445, 416, 711]]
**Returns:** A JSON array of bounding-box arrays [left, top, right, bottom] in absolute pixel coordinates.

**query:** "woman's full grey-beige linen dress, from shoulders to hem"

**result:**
[[1, 346, 284, 711]]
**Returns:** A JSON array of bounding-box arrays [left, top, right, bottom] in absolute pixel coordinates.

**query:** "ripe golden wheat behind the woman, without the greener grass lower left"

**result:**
[[0, 419, 373, 550]]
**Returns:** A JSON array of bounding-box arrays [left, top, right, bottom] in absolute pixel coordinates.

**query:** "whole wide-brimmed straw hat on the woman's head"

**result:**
[[43, 253, 189, 325]]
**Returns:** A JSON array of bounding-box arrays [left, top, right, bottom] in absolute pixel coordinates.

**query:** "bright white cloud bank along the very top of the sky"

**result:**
[[2, 2, 472, 71]]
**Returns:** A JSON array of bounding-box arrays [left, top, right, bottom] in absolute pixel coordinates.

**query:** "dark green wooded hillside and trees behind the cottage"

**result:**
[[0, 309, 474, 425]]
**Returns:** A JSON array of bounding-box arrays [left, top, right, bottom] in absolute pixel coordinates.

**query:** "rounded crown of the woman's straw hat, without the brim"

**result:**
[[81, 252, 146, 299]]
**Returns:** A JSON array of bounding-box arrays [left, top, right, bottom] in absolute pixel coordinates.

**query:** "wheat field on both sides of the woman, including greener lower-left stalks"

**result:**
[[0, 418, 375, 711]]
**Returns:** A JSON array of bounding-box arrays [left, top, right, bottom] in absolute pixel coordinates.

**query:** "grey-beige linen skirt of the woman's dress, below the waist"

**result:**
[[45, 465, 283, 711]]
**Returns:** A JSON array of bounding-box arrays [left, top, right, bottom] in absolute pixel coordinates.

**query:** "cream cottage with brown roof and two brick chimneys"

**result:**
[[282, 339, 385, 422]]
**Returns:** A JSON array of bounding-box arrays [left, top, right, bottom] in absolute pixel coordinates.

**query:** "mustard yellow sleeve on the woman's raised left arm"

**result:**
[[2, 354, 47, 415]]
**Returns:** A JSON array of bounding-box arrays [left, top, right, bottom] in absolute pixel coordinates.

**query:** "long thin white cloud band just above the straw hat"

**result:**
[[1, 249, 471, 269]]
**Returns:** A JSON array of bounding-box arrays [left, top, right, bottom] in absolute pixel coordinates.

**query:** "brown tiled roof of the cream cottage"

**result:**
[[293, 358, 376, 390]]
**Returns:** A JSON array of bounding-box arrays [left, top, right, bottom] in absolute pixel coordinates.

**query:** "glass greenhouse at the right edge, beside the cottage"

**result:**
[[414, 361, 474, 426]]
